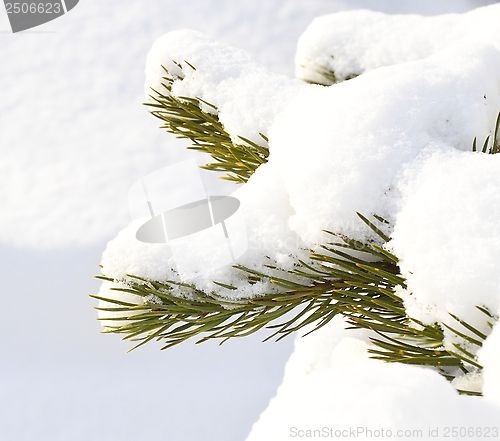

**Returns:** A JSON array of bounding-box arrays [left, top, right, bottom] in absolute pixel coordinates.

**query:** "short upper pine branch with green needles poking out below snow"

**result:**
[[144, 61, 269, 183]]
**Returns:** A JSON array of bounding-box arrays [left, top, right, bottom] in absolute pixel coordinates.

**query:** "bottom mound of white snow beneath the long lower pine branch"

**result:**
[[247, 317, 499, 441]]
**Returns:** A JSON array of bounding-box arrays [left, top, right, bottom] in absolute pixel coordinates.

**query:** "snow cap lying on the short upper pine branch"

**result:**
[[145, 30, 305, 143]]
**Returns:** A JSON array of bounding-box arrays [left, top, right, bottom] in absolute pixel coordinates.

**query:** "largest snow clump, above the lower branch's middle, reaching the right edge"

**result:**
[[272, 43, 500, 245]]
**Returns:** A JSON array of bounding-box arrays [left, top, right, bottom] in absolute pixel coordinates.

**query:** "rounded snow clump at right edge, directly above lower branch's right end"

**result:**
[[392, 151, 500, 349]]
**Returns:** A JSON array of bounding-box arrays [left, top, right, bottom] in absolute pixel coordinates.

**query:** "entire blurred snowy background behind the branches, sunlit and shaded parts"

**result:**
[[0, 0, 500, 441]]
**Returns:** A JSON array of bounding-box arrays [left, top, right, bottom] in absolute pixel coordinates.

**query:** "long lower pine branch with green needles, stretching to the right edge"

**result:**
[[92, 213, 498, 395]]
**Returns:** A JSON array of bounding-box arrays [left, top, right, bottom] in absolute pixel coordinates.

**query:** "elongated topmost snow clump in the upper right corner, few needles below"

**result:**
[[295, 4, 500, 84]]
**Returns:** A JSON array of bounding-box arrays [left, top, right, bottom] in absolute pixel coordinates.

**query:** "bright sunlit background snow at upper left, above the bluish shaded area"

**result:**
[[0, 0, 493, 249]]
